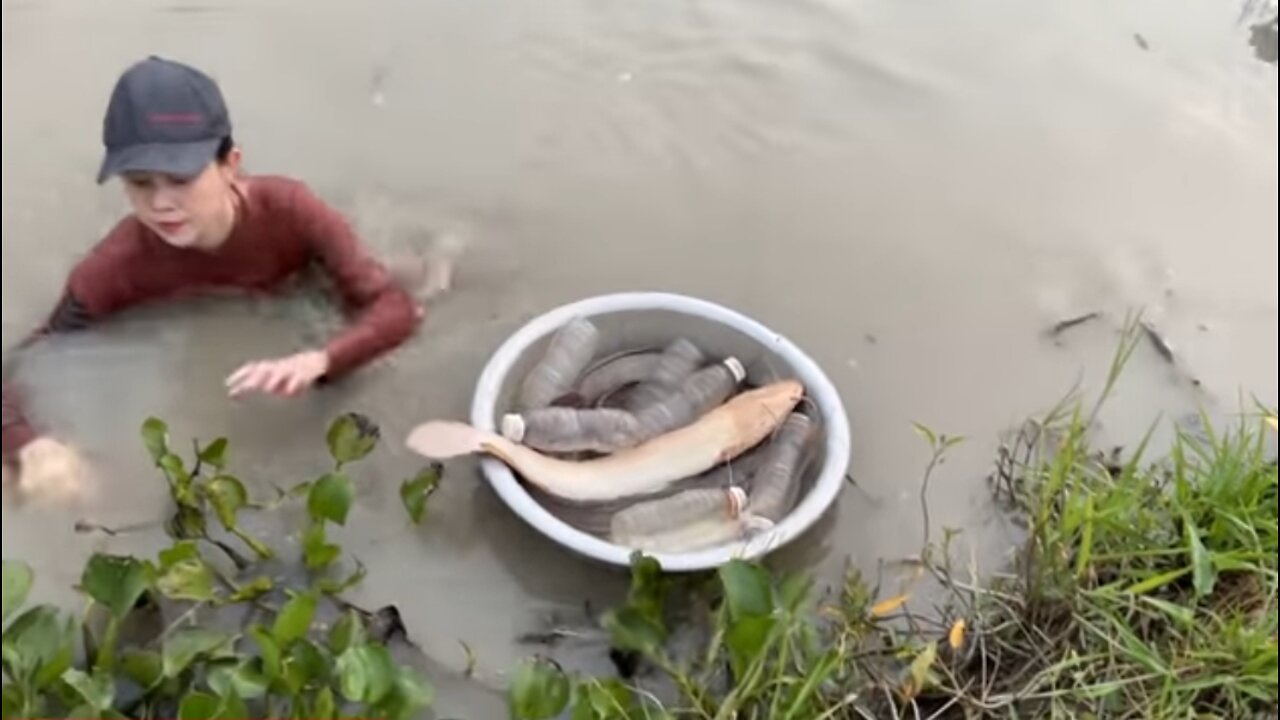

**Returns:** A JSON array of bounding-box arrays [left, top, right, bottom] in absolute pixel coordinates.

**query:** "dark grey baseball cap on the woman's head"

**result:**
[[97, 55, 232, 183]]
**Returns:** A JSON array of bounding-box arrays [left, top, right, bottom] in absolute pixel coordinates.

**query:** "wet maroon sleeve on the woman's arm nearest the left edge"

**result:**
[[0, 222, 145, 462]]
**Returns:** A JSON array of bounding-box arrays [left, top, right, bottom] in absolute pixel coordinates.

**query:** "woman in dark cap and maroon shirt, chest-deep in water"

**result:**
[[3, 56, 448, 502]]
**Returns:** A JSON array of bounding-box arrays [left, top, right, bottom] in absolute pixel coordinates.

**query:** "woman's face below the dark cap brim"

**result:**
[[123, 150, 239, 250]]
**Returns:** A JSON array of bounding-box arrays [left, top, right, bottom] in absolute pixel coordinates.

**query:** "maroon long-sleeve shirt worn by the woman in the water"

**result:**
[[3, 176, 420, 461]]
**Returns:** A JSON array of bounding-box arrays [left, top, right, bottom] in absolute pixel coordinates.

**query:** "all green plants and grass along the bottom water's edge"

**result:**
[[3, 324, 1280, 720]]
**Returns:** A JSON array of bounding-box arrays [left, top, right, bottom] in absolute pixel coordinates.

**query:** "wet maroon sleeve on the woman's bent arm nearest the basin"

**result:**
[[293, 186, 421, 380]]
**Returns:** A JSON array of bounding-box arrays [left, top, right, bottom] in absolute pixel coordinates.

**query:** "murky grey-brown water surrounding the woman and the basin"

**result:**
[[0, 0, 1277, 717]]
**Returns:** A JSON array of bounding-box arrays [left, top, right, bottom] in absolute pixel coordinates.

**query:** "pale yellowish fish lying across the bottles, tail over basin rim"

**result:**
[[406, 379, 804, 501]]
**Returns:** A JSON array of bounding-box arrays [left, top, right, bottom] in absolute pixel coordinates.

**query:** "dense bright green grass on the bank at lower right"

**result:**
[[940, 404, 1277, 717]]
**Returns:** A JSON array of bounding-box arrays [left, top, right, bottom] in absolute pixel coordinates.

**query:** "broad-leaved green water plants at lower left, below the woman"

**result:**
[[3, 413, 439, 720]]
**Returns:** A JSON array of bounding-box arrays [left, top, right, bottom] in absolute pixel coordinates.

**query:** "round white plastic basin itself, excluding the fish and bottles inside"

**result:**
[[471, 292, 850, 571]]
